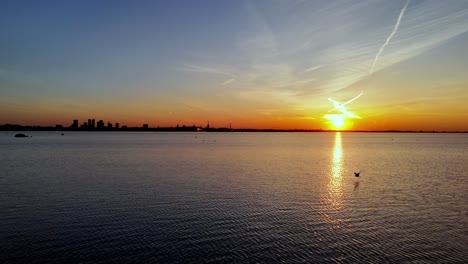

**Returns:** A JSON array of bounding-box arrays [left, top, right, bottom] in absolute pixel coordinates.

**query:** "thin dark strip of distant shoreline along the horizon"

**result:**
[[0, 124, 468, 133]]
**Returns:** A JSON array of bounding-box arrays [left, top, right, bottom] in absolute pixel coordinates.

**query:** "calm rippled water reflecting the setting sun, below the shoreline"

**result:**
[[0, 132, 468, 263]]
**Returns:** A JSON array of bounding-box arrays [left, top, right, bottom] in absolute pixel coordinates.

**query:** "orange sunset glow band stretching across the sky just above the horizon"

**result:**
[[0, 101, 468, 131]]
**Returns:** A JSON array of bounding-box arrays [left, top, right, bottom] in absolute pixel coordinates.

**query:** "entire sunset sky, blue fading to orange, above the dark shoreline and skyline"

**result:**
[[0, 0, 468, 131]]
